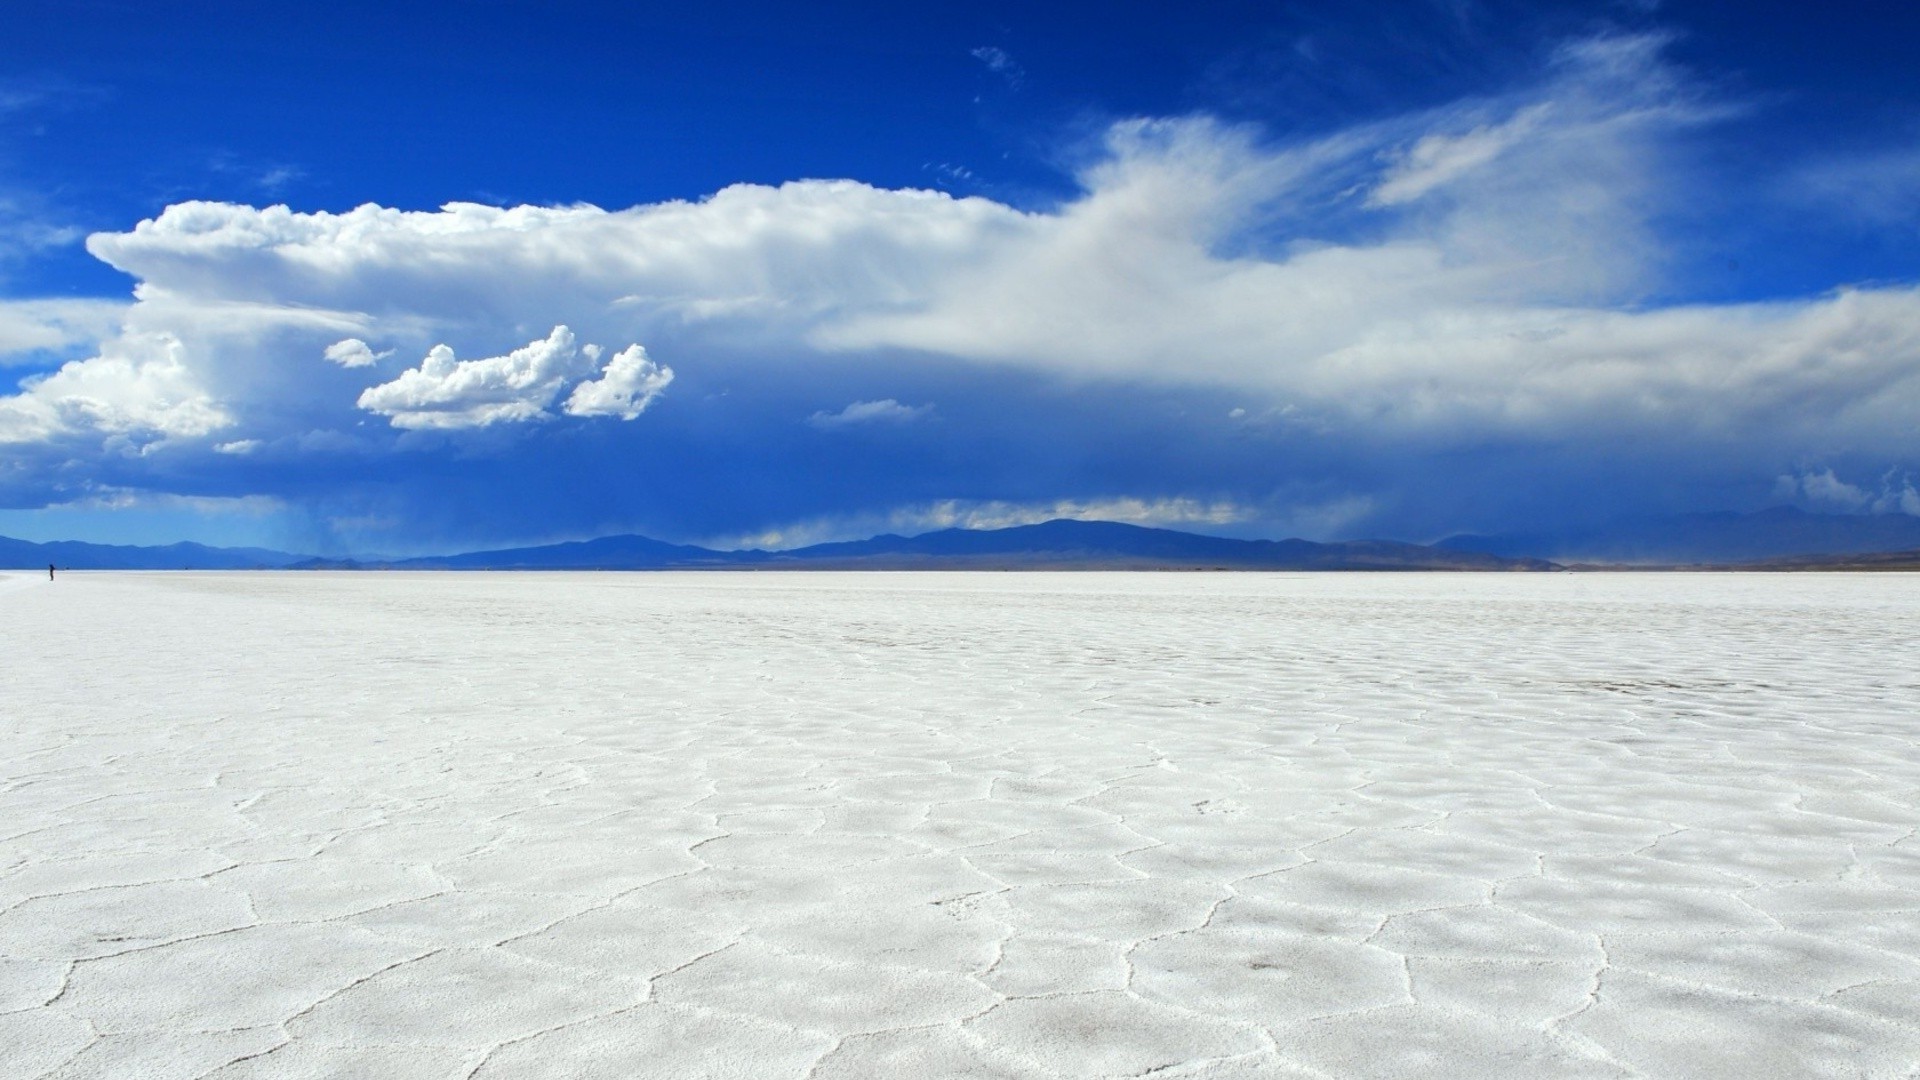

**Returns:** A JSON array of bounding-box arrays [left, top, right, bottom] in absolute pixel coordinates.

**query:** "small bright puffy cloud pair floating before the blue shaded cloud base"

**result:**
[[357, 327, 674, 430]]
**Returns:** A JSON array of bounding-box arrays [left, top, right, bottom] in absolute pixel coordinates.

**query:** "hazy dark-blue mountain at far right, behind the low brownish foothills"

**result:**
[[1436, 507, 1920, 565]]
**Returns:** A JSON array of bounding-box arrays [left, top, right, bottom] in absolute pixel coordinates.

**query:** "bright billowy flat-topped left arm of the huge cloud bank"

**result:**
[[88, 181, 1025, 340]]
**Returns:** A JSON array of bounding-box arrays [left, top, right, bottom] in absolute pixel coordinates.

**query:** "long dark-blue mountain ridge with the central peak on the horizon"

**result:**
[[389, 521, 1551, 571]]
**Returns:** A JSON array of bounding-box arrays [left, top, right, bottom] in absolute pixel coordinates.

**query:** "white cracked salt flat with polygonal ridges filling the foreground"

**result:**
[[0, 573, 1920, 1080]]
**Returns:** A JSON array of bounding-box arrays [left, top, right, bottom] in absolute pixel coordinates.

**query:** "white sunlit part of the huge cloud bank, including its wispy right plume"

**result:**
[[0, 38, 1920, 490]]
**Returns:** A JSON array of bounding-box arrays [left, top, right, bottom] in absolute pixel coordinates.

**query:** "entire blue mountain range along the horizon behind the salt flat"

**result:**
[[11, 507, 1920, 571]]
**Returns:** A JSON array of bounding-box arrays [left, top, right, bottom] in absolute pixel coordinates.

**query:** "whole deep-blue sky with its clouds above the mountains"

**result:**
[[0, 0, 1920, 553]]
